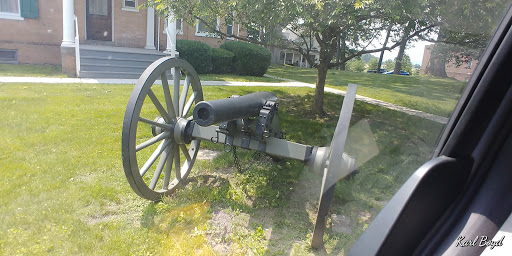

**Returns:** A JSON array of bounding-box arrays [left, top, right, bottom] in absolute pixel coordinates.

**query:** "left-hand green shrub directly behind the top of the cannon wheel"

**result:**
[[176, 40, 212, 74]]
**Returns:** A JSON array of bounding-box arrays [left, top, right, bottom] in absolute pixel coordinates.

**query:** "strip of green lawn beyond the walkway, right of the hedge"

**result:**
[[267, 65, 465, 117]]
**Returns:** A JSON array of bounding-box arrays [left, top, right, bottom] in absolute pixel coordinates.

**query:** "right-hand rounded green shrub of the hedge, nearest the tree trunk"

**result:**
[[220, 41, 271, 76]]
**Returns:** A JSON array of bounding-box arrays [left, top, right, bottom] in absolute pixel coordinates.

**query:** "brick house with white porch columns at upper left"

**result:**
[[0, 0, 246, 76]]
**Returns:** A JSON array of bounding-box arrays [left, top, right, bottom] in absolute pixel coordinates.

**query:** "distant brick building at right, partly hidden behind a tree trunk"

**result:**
[[420, 44, 478, 81]]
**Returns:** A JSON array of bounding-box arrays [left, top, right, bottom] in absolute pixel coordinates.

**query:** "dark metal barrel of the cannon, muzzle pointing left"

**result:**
[[194, 92, 278, 126]]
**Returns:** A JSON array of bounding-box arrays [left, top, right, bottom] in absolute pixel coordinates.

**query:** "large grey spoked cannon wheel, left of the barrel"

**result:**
[[122, 57, 203, 201]]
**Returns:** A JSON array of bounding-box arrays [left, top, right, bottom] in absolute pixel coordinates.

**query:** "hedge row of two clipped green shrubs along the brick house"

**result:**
[[176, 40, 271, 76]]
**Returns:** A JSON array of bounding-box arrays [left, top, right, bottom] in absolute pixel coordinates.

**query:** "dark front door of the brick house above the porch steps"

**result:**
[[85, 0, 112, 41]]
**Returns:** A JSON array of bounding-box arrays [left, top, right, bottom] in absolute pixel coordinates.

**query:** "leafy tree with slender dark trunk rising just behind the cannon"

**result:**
[[154, 0, 434, 114]]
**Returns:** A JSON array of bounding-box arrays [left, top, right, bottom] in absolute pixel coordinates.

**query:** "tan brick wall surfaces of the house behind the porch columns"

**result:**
[[0, 0, 247, 65]]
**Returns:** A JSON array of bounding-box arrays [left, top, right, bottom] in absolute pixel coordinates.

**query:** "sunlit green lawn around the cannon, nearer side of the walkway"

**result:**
[[0, 83, 442, 255]]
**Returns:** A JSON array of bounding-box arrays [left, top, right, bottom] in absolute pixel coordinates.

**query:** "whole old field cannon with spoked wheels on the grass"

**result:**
[[122, 57, 357, 248]]
